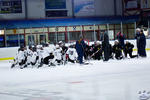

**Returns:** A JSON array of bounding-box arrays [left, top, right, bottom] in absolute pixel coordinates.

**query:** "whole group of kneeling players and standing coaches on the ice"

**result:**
[[11, 29, 146, 69]]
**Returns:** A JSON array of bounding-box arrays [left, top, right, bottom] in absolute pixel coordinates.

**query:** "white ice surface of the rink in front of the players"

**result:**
[[0, 51, 150, 100]]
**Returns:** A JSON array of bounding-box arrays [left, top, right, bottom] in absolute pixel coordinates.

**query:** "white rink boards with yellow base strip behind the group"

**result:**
[[0, 39, 150, 61]]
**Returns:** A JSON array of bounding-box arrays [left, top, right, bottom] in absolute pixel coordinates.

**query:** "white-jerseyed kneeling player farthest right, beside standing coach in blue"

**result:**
[[66, 45, 78, 63]]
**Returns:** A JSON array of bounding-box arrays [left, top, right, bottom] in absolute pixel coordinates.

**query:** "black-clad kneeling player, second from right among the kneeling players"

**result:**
[[113, 41, 123, 60]]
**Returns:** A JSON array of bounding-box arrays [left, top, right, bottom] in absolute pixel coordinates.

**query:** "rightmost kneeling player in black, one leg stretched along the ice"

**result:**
[[124, 41, 137, 58]]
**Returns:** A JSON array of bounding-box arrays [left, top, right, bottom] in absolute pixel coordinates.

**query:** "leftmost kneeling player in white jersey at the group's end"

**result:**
[[11, 46, 27, 69]]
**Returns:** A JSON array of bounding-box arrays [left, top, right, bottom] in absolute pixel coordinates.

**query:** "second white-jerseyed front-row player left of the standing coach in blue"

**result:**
[[54, 45, 62, 65]]
